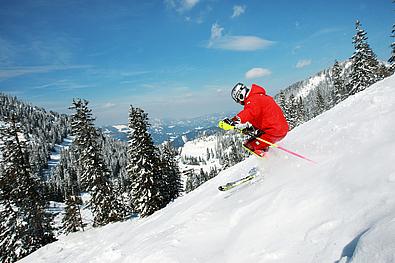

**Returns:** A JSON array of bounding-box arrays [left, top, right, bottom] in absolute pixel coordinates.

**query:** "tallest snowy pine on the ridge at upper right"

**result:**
[[347, 20, 379, 95]]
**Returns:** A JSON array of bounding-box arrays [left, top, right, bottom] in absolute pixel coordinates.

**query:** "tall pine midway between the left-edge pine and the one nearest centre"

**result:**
[[70, 99, 123, 227]]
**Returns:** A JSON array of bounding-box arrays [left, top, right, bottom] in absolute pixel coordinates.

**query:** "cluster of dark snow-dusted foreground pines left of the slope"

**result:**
[[0, 99, 183, 262]]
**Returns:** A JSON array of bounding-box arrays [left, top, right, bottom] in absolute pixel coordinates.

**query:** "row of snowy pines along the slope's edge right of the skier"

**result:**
[[277, 20, 395, 129]]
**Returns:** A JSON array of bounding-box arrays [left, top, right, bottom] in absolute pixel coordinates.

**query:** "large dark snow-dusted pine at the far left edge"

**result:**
[[0, 115, 55, 262]]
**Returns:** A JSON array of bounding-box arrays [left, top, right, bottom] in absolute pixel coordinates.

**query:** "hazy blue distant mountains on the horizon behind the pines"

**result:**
[[101, 112, 235, 147]]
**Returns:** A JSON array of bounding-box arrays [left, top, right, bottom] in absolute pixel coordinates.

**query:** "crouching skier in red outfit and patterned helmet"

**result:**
[[223, 83, 289, 157]]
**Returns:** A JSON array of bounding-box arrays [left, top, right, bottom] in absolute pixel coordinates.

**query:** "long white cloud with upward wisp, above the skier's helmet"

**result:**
[[207, 23, 274, 51]]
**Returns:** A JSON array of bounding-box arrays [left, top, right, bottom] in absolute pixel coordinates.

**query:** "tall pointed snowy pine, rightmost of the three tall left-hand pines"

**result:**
[[127, 106, 165, 217]]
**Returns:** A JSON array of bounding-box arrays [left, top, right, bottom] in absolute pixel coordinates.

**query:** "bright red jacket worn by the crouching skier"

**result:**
[[236, 84, 289, 137]]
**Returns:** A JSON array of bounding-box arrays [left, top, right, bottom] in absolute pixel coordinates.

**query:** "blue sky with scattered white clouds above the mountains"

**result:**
[[0, 0, 395, 125]]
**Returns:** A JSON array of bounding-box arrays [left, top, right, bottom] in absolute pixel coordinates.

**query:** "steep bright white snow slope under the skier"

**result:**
[[21, 76, 395, 263]]
